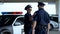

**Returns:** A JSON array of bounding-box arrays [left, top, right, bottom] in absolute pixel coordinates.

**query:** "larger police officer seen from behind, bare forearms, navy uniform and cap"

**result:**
[[32, 2, 50, 34]]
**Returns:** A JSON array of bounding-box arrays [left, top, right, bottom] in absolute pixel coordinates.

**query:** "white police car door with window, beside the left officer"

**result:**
[[13, 17, 24, 34]]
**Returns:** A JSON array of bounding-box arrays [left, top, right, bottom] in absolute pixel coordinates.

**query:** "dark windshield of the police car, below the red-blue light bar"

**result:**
[[0, 15, 16, 27]]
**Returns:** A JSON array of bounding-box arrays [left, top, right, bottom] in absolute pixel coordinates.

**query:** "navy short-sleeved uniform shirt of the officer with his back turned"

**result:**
[[33, 8, 50, 25]]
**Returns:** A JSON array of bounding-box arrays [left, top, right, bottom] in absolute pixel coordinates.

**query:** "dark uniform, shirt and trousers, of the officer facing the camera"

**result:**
[[24, 13, 32, 34]]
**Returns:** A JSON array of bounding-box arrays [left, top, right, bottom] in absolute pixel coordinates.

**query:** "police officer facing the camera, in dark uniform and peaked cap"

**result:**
[[24, 5, 32, 34]]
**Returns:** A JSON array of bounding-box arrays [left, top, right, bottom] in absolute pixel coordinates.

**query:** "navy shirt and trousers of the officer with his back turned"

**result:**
[[34, 8, 50, 34]]
